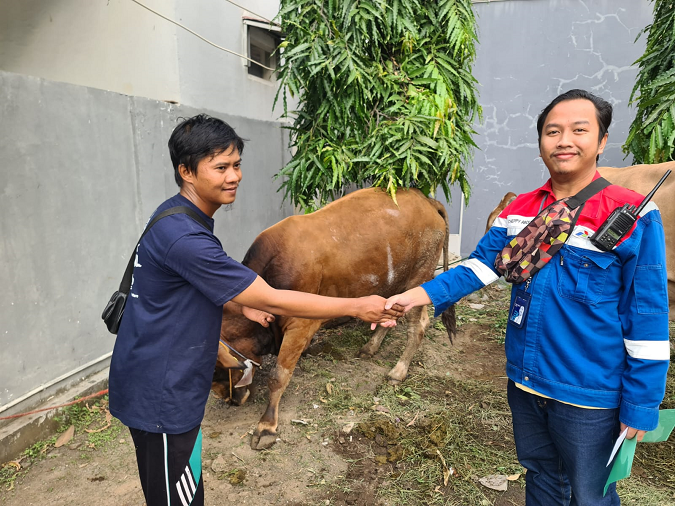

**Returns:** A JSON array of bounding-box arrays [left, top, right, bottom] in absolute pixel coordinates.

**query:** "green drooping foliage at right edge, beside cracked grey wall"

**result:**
[[623, 0, 675, 164]]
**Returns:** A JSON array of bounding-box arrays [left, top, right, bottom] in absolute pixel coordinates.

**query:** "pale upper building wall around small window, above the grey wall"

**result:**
[[0, 0, 281, 120]]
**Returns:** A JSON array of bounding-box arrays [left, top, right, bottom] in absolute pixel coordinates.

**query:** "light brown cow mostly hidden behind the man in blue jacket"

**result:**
[[486, 162, 675, 320]]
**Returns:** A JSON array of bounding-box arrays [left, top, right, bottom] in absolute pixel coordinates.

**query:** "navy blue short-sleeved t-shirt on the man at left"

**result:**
[[109, 194, 256, 434]]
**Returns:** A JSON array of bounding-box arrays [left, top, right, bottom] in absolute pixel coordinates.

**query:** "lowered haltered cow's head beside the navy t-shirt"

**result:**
[[211, 314, 274, 405]]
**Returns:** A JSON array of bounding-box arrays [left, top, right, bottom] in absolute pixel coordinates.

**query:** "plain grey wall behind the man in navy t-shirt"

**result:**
[[0, 71, 292, 415]]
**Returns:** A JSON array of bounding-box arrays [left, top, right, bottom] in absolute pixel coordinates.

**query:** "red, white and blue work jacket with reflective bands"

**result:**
[[422, 172, 670, 431]]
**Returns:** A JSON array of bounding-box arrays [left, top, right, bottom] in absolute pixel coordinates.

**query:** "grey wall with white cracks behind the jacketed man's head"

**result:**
[[450, 0, 652, 255]]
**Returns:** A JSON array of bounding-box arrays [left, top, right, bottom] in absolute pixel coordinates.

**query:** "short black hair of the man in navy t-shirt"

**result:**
[[169, 114, 244, 186]]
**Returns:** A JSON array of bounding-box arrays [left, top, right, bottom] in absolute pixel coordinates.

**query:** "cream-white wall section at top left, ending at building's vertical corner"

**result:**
[[0, 0, 181, 102]]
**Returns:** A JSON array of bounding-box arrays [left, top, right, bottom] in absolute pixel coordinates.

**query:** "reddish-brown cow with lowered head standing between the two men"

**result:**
[[217, 188, 454, 449]]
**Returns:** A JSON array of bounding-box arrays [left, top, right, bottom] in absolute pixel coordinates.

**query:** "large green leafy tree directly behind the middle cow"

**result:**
[[276, 0, 482, 210]]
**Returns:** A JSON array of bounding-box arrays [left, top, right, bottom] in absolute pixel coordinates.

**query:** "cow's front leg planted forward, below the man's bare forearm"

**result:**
[[251, 318, 323, 450]]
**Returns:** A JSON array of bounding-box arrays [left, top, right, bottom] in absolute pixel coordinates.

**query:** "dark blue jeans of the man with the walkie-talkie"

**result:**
[[508, 380, 621, 506]]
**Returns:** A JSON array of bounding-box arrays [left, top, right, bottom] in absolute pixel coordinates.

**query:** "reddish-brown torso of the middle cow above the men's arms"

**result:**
[[244, 188, 447, 297]]
